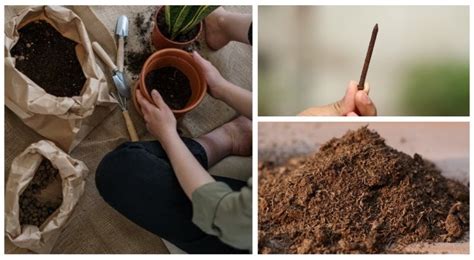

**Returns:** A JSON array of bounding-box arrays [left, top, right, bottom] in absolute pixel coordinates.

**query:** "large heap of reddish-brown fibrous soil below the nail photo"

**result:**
[[258, 127, 469, 253]]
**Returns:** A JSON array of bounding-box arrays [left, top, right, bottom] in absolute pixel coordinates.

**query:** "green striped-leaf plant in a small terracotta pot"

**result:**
[[151, 5, 219, 50]]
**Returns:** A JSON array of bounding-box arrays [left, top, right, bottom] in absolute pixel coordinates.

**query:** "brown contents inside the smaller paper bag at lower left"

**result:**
[[20, 159, 62, 227]]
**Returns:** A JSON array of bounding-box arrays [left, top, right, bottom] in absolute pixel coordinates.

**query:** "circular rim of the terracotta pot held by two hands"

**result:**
[[137, 48, 207, 114]]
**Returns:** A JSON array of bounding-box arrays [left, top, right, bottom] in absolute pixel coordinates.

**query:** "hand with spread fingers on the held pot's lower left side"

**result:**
[[136, 88, 176, 142]]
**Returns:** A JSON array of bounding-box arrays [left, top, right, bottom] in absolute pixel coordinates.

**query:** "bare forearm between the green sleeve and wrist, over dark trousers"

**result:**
[[160, 132, 215, 199]]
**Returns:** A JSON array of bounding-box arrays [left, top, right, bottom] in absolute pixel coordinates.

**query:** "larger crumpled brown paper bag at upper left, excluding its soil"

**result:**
[[5, 6, 116, 151]]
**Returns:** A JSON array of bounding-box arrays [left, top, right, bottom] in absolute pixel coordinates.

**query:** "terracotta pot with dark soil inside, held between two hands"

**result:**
[[133, 48, 207, 117]]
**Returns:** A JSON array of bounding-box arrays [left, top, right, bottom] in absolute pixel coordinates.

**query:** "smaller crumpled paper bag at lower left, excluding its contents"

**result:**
[[5, 140, 89, 253]]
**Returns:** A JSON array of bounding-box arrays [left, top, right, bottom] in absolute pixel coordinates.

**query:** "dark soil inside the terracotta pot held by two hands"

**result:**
[[145, 67, 191, 110]]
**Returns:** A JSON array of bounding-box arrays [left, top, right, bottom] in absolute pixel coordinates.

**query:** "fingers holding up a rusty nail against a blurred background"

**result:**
[[298, 81, 377, 116]]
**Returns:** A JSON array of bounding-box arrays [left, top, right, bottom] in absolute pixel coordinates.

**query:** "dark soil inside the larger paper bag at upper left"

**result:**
[[10, 20, 86, 97]]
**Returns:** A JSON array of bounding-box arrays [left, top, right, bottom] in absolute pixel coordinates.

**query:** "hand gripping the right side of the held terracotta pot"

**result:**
[[193, 51, 228, 99]]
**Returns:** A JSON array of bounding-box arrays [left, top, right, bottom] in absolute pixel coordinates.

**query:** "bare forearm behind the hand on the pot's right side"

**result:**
[[220, 81, 252, 119]]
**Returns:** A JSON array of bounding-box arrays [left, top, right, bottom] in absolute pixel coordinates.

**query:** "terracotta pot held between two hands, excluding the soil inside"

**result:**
[[132, 48, 207, 117]]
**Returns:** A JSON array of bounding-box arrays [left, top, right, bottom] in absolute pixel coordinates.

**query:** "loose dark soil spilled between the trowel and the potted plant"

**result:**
[[125, 13, 153, 75]]
